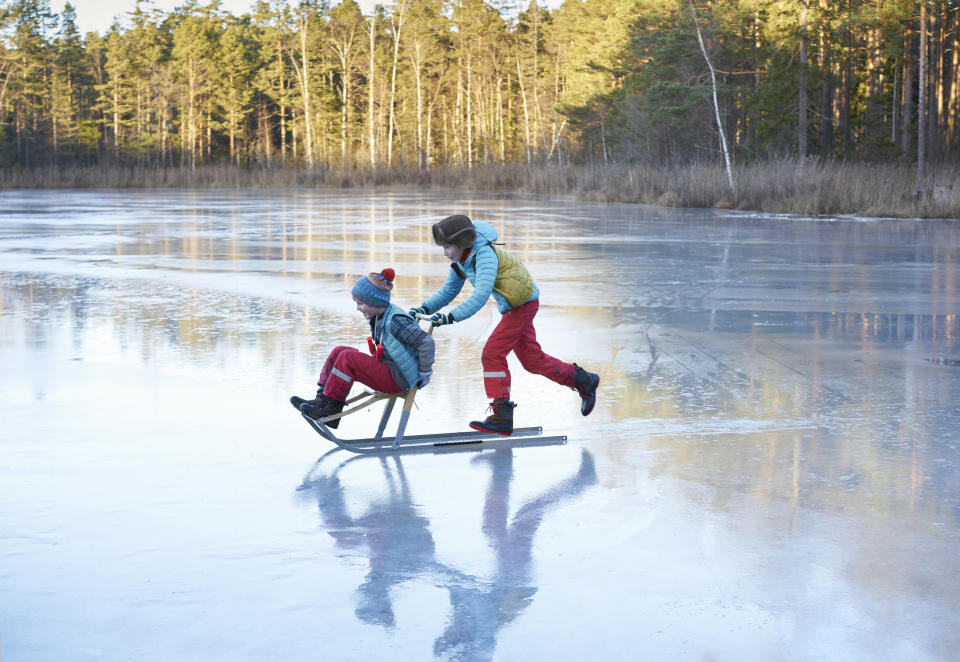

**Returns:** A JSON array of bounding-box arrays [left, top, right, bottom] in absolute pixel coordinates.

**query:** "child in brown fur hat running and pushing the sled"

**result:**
[[410, 214, 600, 436]]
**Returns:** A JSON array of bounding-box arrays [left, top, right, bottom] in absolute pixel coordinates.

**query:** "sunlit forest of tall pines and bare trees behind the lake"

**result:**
[[0, 0, 960, 215]]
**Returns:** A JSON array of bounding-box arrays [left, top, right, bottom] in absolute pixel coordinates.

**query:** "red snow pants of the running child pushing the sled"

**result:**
[[480, 299, 576, 398]]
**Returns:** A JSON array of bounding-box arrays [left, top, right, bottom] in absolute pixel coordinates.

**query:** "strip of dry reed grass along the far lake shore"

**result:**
[[0, 159, 960, 218]]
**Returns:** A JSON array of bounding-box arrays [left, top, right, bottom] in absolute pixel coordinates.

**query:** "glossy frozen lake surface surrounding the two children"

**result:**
[[0, 190, 960, 662]]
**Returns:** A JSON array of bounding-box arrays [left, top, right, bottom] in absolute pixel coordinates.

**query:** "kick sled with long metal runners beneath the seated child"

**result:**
[[300, 387, 567, 454]]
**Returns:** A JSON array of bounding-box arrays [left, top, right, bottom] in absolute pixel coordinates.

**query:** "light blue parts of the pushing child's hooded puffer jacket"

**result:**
[[423, 221, 540, 322]]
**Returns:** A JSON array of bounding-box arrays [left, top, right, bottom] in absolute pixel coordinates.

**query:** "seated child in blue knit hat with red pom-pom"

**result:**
[[290, 269, 435, 428]]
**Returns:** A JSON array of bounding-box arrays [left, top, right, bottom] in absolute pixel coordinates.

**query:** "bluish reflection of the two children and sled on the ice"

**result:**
[[297, 449, 597, 660]]
